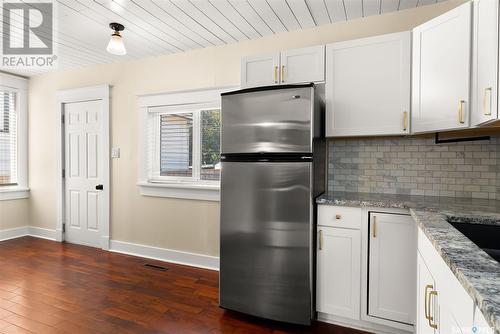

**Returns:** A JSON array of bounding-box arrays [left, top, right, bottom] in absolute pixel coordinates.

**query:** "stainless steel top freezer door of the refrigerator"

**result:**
[[221, 87, 314, 154]]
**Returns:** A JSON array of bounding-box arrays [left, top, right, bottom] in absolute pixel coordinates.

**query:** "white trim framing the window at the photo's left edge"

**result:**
[[0, 73, 29, 201]]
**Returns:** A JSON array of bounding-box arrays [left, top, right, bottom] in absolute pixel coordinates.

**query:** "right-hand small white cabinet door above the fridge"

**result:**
[[280, 45, 325, 84]]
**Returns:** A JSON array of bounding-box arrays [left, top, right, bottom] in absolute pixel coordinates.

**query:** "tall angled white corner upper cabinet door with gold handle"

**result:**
[[412, 2, 472, 132]]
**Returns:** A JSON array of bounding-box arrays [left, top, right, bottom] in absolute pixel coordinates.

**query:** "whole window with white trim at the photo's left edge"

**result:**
[[0, 73, 28, 200]]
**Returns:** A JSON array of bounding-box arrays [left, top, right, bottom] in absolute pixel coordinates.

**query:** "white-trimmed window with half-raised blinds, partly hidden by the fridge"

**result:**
[[139, 89, 233, 201]]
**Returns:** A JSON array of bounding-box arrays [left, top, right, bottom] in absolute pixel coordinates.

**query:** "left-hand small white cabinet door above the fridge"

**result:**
[[241, 53, 280, 87]]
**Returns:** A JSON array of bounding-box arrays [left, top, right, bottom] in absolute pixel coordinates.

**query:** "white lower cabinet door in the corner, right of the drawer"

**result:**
[[368, 212, 417, 325]]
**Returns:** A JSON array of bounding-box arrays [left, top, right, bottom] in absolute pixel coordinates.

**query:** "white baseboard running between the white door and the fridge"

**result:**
[[109, 240, 219, 270]]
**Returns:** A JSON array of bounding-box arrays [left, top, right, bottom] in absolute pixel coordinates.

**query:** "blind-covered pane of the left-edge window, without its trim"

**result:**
[[0, 89, 17, 186]]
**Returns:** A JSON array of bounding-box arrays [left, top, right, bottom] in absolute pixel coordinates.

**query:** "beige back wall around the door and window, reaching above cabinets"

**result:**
[[29, 0, 460, 255]]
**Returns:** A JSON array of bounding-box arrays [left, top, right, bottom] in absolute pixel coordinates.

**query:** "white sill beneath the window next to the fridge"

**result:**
[[137, 181, 220, 202]]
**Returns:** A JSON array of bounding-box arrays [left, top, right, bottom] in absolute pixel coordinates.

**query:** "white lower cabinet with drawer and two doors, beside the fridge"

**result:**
[[316, 205, 417, 333]]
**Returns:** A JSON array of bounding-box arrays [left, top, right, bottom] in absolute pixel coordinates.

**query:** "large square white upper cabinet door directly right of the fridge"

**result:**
[[325, 32, 411, 137]]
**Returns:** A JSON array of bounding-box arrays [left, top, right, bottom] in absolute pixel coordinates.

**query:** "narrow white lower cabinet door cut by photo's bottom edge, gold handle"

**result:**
[[415, 253, 438, 334]]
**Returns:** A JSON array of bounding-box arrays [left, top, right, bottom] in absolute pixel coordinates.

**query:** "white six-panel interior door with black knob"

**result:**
[[64, 100, 108, 247]]
